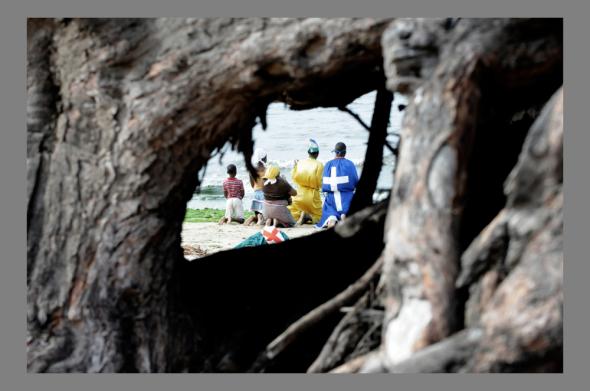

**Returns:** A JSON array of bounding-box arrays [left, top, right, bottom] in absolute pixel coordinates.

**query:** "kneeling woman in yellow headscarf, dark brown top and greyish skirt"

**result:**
[[262, 166, 297, 227]]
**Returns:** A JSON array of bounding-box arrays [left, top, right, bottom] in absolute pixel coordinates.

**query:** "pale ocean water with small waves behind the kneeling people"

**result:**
[[187, 92, 405, 209]]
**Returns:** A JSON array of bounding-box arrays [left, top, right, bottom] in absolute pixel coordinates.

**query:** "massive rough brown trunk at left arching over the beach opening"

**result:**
[[27, 19, 396, 372]]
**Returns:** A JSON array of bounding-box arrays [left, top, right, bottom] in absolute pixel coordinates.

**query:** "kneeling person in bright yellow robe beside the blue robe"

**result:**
[[289, 139, 324, 225]]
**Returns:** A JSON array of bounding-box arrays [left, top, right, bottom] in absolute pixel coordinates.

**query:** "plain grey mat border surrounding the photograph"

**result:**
[[0, 0, 590, 391]]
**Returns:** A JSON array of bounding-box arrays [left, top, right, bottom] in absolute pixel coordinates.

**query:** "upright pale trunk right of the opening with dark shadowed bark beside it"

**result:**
[[370, 19, 562, 369]]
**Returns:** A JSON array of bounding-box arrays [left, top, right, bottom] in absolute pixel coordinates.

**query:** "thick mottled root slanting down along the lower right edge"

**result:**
[[362, 89, 563, 373]]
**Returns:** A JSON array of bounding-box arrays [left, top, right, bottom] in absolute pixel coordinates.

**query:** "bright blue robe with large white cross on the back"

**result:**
[[317, 158, 359, 227]]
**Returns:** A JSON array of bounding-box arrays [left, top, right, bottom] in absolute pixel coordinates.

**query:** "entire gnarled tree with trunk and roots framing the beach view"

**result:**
[[27, 19, 562, 372]]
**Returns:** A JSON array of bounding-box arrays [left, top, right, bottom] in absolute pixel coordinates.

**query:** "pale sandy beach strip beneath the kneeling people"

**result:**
[[181, 223, 316, 259]]
